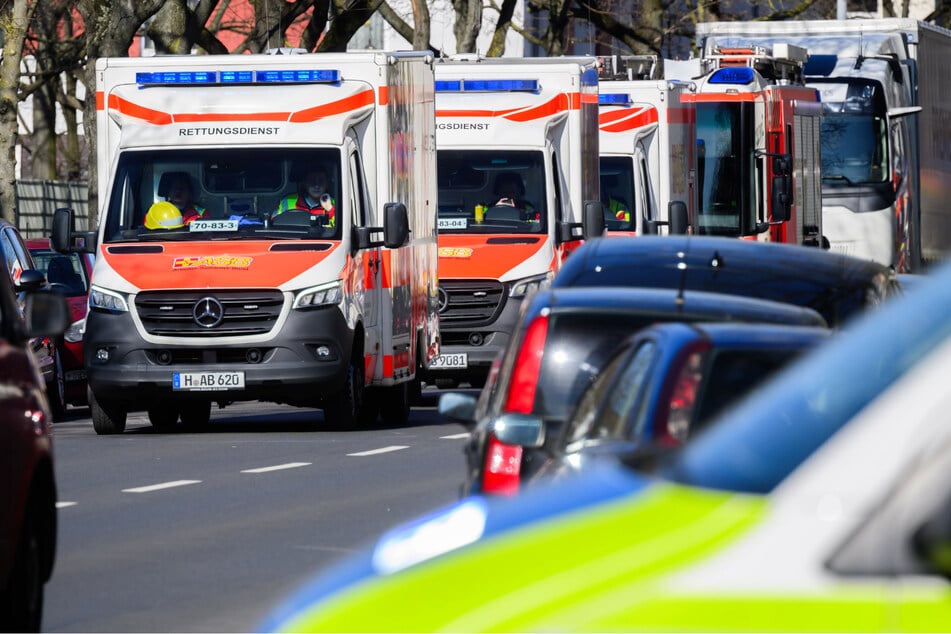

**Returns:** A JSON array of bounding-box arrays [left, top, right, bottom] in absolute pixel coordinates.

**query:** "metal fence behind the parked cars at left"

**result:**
[[16, 180, 89, 239]]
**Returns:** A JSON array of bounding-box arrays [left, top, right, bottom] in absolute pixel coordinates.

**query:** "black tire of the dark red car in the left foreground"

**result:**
[[0, 504, 44, 632]]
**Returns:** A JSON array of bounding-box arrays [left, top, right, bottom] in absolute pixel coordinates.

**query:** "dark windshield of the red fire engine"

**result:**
[[697, 103, 754, 237]]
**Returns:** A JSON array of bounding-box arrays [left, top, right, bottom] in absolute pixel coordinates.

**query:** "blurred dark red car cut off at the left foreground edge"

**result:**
[[0, 236, 69, 632]]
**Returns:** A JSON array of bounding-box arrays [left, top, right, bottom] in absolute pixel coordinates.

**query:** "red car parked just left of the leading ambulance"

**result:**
[[26, 238, 94, 420]]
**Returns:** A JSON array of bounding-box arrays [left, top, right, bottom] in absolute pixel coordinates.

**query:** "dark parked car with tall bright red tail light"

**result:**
[[439, 284, 826, 495]]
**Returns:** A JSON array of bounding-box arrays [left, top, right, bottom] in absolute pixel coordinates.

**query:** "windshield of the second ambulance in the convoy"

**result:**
[[436, 150, 548, 233]]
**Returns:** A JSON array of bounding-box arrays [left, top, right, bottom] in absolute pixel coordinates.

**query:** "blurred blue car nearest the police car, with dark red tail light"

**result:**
[[528, 323, 833, 479]]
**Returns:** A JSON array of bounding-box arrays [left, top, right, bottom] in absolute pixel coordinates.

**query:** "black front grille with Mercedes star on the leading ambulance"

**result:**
[[135, 289, 284, 337]]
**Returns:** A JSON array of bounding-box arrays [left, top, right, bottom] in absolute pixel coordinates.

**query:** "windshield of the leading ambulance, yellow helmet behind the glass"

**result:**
[[104, 147, 345, 242]]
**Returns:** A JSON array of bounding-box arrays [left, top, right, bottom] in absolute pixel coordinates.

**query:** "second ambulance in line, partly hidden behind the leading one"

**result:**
[[426, 56, 604, 387]]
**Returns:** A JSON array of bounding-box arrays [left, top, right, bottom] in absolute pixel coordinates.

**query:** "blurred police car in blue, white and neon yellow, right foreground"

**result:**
[[261, 256, 951, 632]]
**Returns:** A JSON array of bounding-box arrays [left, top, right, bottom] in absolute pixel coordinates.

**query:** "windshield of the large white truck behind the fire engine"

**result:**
[[815, 83, 888, 187]]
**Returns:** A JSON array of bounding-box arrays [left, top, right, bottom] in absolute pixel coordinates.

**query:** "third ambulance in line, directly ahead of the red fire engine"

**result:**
[[598, 55, 697, 235]]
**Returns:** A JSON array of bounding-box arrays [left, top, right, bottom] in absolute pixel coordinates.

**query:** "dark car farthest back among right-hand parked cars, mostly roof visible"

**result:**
[[552, 236, 902, 327]]
